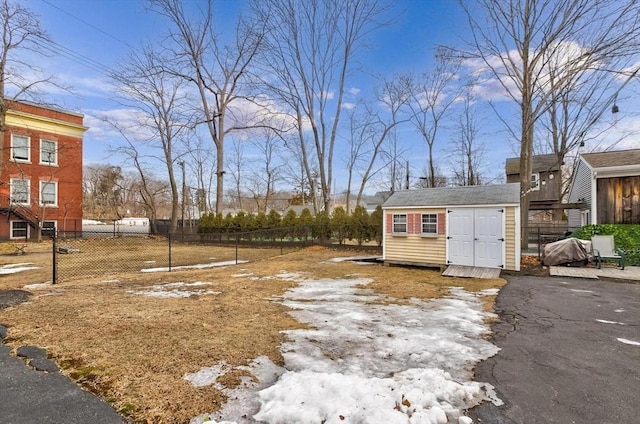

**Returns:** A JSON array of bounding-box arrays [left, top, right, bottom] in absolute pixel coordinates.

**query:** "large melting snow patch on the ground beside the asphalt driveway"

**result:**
[[194, 272, 502, 424]]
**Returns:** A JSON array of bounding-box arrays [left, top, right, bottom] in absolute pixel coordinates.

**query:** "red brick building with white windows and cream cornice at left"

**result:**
[[0, 102, 87, 240]]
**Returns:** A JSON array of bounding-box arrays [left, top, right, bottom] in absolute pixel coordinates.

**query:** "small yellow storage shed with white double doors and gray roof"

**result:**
[[382, 183, 520, 271]]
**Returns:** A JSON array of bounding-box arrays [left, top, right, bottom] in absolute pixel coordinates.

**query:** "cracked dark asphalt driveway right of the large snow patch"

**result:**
[[470, 276, 640, 424]]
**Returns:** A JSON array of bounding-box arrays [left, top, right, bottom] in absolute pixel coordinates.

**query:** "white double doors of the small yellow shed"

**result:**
[[447, 207, 504, 268]]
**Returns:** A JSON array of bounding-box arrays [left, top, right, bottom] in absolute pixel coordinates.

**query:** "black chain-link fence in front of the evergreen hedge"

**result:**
[[52, 226, 380, 282]]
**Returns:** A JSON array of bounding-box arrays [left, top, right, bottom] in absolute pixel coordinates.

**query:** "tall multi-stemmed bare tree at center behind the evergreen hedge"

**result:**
[[252, 0, 387, 211]]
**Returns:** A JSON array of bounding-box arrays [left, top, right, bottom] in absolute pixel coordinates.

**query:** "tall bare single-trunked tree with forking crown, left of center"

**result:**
[[149, 0, 266, 213]]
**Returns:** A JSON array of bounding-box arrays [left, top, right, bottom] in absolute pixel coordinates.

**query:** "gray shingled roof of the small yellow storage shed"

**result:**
[[382, 183, 520, 208]]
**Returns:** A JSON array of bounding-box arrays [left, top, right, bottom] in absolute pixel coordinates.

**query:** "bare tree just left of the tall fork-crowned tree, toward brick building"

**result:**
[[112, 48, 190, 234]]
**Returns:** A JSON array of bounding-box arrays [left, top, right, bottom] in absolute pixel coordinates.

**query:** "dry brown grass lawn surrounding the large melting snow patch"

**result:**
[[0, 243, 504, 423]]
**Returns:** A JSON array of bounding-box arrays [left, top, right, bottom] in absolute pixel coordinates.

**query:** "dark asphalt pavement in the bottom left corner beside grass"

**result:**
[[0, 325, 124, 424]]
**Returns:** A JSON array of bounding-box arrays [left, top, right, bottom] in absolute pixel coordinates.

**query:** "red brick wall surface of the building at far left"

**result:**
[[0, 103, 83, 238]]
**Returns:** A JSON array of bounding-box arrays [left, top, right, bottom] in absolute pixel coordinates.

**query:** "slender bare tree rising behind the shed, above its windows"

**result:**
[[409, 52, 460, 187]]
